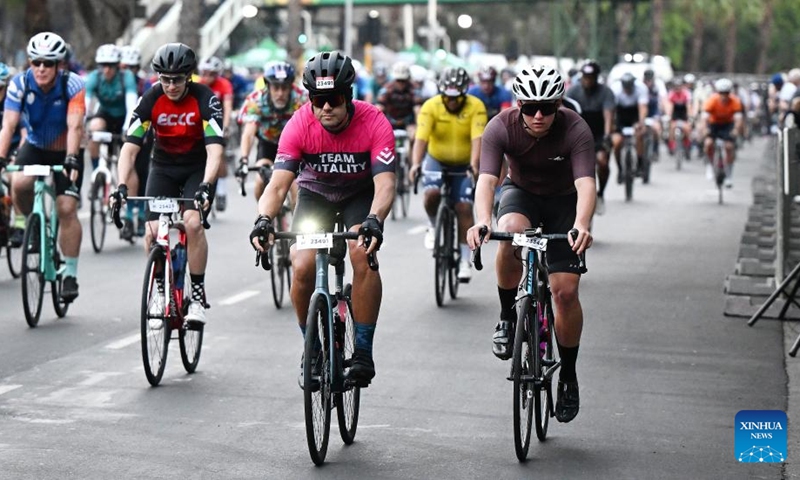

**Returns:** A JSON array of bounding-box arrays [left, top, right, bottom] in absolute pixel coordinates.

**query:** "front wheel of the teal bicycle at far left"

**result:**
[[22, 213, 44, 328]]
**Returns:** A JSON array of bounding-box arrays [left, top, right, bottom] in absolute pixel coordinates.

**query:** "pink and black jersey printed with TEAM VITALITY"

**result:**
[[275, 100, 396, 202]]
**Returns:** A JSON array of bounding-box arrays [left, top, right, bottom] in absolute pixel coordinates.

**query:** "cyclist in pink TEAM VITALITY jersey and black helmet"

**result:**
[[250, 51, 395, 388]]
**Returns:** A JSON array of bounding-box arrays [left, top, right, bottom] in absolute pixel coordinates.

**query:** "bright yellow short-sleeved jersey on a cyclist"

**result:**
[[415, 95, 486, 166]]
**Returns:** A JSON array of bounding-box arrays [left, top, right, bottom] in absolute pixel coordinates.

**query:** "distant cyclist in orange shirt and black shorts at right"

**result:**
[[703, 78, 743, 188]]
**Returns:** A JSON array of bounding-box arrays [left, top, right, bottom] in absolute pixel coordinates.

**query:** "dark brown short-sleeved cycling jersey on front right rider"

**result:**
[[480, 108, 596, 195]]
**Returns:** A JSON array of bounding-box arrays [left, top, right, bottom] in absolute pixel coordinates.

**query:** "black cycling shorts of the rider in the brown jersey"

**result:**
[[497, 179, 586, 275]]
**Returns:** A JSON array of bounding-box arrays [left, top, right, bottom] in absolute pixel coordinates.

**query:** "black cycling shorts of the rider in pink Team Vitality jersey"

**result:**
[[292, 186, 375, 232]]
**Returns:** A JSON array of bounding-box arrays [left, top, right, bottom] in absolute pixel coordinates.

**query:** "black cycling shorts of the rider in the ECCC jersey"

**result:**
[[146, 161, 217, 220]]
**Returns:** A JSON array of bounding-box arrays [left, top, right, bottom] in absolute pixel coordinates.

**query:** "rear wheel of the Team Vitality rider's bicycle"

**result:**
[[333, 283, 361, 445]]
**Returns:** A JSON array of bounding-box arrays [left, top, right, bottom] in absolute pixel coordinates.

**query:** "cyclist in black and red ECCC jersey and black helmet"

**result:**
[[115, 43, 223, 323]]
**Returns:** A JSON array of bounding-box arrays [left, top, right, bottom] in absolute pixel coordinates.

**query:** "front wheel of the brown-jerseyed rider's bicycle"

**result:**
[[511, 296, 538, 462]]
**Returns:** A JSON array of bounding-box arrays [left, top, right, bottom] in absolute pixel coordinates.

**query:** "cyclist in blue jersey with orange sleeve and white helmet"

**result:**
[[0, 32, 86, 302]]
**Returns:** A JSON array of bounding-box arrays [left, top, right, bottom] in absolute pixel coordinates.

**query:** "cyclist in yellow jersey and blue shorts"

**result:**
[[409, 67, 486, 282]]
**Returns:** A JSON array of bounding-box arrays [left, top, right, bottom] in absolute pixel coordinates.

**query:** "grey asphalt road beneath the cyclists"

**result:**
[[0, 140, 787, 479]]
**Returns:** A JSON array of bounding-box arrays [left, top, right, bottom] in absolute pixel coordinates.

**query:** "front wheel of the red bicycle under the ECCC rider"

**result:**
[[141, 247, 172, 387]]
